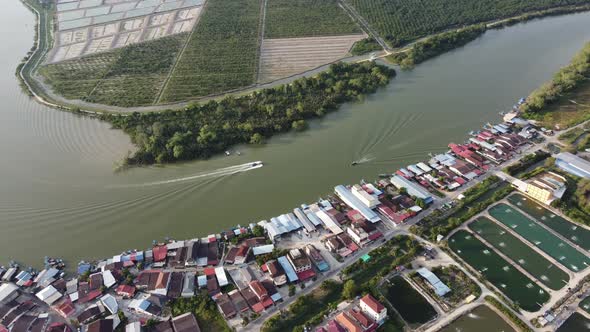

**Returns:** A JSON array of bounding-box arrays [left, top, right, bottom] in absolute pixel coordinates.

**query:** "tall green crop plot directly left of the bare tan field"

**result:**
[[161, 0, 261, 102]]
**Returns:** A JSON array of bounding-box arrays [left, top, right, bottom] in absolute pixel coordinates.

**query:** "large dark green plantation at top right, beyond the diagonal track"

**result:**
[[345, 0, 587, 46]]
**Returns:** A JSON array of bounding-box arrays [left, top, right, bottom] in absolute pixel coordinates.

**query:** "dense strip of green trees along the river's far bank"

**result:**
[[100, 62, 395, 165]]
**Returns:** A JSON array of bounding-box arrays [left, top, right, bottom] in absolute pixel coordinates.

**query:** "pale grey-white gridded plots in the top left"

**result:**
[[47, 0, 204, 63]]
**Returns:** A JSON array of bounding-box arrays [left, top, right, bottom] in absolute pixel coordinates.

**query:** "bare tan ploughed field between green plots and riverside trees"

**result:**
[[258, 35, 364, 82]]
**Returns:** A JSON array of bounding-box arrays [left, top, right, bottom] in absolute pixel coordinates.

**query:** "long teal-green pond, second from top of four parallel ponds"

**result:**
[[489, 204, 590, 272]]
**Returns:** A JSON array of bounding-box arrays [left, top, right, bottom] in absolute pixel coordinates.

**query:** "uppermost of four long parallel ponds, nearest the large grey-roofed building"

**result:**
[[508, 195, 590, 250]]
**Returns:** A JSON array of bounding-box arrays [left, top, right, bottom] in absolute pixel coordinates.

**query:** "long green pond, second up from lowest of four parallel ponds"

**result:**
[[469, 217, 569, 290]]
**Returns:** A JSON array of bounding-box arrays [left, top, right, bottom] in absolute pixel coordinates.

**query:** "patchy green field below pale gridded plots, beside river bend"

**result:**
[[40, 34, 187, 106]]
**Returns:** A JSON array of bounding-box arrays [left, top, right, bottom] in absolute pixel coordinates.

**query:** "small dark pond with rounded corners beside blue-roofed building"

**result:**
[[382, 276, 436, 327]]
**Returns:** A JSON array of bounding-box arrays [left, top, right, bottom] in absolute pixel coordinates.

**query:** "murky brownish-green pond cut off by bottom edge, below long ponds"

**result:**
[[439, 305, 514, 332]]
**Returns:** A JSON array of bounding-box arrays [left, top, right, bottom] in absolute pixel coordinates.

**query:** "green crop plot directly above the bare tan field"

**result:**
[[264, 0, 362, 38]]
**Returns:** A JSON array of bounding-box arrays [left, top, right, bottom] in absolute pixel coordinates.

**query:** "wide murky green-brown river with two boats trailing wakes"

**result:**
[[0, 0, 590, 265]]
